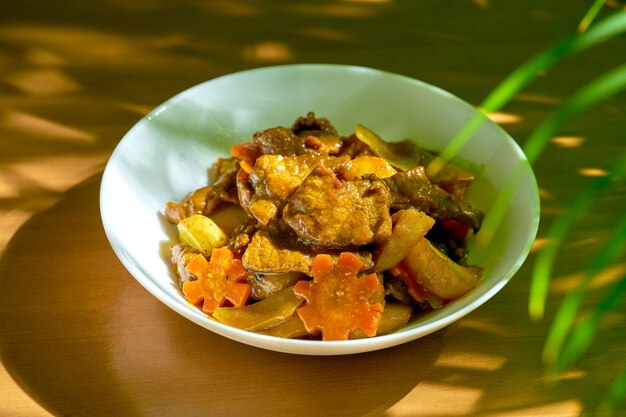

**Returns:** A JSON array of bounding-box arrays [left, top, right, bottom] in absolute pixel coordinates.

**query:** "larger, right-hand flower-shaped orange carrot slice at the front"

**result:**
[[294, 252, 383, 340]]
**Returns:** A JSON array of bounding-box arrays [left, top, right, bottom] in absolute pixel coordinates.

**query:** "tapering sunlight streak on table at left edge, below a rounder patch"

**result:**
[[0, 110, 97, 143]]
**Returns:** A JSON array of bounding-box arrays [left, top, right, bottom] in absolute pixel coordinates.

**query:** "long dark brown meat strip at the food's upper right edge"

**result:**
[[382, 166, 484, 232]]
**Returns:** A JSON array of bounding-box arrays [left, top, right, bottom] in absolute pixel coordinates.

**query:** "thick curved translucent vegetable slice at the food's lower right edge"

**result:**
[[404, 238, 482, 300]]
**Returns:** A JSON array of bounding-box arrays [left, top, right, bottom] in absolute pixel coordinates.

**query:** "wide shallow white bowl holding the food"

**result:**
[[100, 64, 539, 355]]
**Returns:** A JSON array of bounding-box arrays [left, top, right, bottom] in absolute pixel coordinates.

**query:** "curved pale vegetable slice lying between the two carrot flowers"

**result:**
[[213, 287, 303, 331]]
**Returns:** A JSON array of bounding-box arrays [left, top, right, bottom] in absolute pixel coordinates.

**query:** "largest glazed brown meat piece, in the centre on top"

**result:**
[[283, 165, 391, 248]]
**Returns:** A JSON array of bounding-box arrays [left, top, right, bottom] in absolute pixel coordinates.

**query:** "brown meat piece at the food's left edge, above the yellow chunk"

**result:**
[[165, 158, 239, 223]]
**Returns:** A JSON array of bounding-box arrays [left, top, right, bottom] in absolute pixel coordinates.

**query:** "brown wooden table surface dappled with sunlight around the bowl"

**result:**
[[0, 0, 626, 417]]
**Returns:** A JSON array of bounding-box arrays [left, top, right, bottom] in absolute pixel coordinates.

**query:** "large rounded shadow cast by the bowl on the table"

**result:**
[[0, 176, 442, 416]]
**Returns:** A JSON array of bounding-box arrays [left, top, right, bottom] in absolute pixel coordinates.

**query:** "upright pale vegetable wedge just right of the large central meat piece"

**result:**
[[374, 209, 435, 272]]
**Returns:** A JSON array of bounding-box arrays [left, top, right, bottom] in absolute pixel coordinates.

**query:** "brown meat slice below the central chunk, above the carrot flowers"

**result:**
[[241, 228, 374, 275]]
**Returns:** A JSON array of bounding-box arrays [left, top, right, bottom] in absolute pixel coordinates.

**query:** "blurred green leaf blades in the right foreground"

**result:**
[[428, 0, 626, 416]]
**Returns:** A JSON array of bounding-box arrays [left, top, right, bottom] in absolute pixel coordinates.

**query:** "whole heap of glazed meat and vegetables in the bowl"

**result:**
[[165, 113, 483, 340]]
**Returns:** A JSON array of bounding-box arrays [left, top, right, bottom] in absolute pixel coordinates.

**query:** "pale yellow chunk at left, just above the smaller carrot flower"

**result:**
[[176, 214, 228, 257]]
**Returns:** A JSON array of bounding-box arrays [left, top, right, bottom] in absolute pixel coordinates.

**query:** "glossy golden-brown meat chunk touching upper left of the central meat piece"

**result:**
[[246, 154, 345, 225]]
